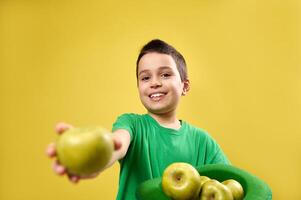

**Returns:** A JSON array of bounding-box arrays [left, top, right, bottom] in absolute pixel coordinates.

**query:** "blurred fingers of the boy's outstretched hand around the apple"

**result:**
[[46, 122, 122, 183]]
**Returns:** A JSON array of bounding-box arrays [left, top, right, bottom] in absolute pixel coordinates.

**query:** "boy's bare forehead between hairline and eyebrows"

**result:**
[[138, 53, 177, 73]]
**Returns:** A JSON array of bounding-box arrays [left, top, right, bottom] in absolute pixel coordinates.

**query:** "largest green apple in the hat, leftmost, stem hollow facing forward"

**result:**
[[162, 162, 201, 200]]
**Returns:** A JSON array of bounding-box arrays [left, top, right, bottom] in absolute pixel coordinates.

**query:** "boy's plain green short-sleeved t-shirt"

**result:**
[[112, 114, 229, 200]]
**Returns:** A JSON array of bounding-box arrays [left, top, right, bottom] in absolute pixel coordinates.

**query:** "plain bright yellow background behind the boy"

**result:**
[[0, 0, 301, 200]]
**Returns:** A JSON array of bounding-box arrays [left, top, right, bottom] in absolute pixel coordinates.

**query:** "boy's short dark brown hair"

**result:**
[[136, 39, 188, 81]]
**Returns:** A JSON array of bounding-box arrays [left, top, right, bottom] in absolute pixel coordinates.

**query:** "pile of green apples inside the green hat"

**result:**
[[162, 162, 244, 200]]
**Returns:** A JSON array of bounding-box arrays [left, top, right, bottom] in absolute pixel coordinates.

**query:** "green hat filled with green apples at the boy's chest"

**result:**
[[137, 162, 272, 200]]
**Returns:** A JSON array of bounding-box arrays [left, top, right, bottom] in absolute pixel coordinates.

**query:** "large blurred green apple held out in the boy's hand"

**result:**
[[56, 127, 114, 176]]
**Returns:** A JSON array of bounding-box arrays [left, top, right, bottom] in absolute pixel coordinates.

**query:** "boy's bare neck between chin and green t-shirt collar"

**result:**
[[148, 112, 181, 129]]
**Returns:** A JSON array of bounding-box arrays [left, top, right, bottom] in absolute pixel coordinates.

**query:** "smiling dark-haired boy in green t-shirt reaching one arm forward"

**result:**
[[48, 40, 229, 200]]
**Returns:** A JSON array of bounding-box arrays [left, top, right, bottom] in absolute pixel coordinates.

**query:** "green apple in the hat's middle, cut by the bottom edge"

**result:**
[[200, 179, 233, 200]]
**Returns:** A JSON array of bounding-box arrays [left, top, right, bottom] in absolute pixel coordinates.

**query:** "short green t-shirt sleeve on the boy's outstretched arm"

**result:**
[[112, 114, 136, 141]]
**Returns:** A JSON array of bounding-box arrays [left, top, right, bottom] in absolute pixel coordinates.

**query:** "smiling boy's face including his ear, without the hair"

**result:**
[[138, 53, 189, 114]]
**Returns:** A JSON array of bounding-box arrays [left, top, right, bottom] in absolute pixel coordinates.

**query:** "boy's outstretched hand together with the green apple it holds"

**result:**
[[47, 123, 116, 183]]
